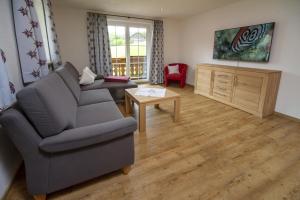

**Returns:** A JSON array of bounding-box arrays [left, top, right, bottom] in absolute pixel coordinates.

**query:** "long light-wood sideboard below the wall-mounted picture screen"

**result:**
[[194, 64, 281, 117]]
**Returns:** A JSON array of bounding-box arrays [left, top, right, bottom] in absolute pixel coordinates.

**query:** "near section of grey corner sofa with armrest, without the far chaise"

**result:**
[[0, 71, 137, 197]]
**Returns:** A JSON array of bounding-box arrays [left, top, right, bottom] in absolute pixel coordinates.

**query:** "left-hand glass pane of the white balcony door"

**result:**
[[108, 26, 127, 76]]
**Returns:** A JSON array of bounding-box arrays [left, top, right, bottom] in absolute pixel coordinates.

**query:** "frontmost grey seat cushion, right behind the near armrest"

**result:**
[[76, 101, 123, 127]]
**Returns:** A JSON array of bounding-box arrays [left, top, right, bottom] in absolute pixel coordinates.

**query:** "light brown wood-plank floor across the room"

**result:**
[[7, 87, 300, 200]]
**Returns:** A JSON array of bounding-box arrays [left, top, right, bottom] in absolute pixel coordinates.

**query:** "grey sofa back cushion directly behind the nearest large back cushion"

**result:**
[[56, 67, 81, 102]]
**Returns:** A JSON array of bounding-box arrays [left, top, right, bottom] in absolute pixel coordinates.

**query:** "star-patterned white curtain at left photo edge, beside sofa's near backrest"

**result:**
[[0, 49, 15, 112]]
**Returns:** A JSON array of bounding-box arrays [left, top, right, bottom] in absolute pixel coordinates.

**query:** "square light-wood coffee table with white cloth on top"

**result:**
[[125, 86, 180, 133]]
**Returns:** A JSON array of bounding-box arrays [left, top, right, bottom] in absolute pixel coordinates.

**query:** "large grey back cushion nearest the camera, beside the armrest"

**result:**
[[17, 73, 77, 137]]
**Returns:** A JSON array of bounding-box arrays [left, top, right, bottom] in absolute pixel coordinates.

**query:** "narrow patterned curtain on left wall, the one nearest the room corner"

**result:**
[[43, 0, 62, 68]]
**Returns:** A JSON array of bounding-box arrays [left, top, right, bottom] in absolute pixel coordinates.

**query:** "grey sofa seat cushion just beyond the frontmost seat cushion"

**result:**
[[79, 89, 113, 106]]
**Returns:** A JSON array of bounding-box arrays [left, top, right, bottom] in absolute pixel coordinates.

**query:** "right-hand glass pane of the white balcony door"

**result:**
[[129, 27, 147, 79]]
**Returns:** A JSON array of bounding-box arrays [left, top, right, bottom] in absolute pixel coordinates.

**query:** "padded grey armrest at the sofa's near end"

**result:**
[[39, 117, 137, 153]]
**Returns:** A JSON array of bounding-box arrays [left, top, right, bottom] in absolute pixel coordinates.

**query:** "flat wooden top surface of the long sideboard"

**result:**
[[197, 63, 281, 73]]
